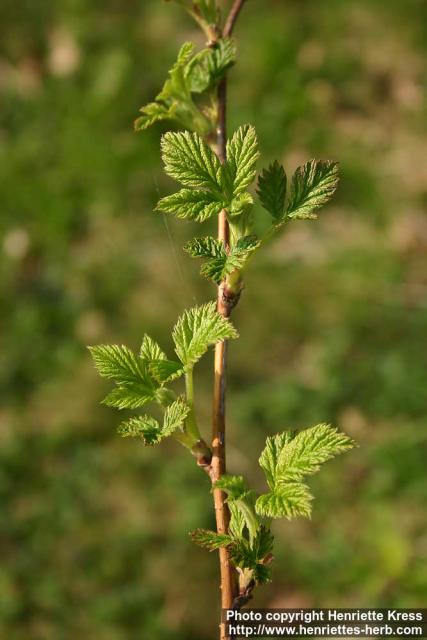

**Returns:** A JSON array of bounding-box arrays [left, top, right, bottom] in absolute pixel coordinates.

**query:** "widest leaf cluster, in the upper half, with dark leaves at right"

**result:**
[[157, 125, 338, 287]]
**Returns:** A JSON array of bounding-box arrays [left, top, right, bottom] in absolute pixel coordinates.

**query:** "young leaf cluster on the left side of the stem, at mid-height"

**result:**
[[89, 302, 237, 444]]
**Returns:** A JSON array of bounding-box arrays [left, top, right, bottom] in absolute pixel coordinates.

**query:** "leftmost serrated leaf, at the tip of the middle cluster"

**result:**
[[88, 344, 146, 382]]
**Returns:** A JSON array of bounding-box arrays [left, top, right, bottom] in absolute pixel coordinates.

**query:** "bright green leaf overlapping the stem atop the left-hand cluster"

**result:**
[[172, 302, 238, 369]]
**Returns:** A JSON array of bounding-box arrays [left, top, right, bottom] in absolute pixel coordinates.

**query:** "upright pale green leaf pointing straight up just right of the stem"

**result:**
[[225, 124, 259, 197]]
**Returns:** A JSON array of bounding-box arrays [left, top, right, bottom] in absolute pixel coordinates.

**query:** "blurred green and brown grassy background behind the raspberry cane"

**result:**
[[0, 0, 427, 640]]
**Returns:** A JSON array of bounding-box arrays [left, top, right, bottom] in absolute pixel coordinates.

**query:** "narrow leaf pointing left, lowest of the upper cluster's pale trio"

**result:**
[[156, 189, 224, 222]]
